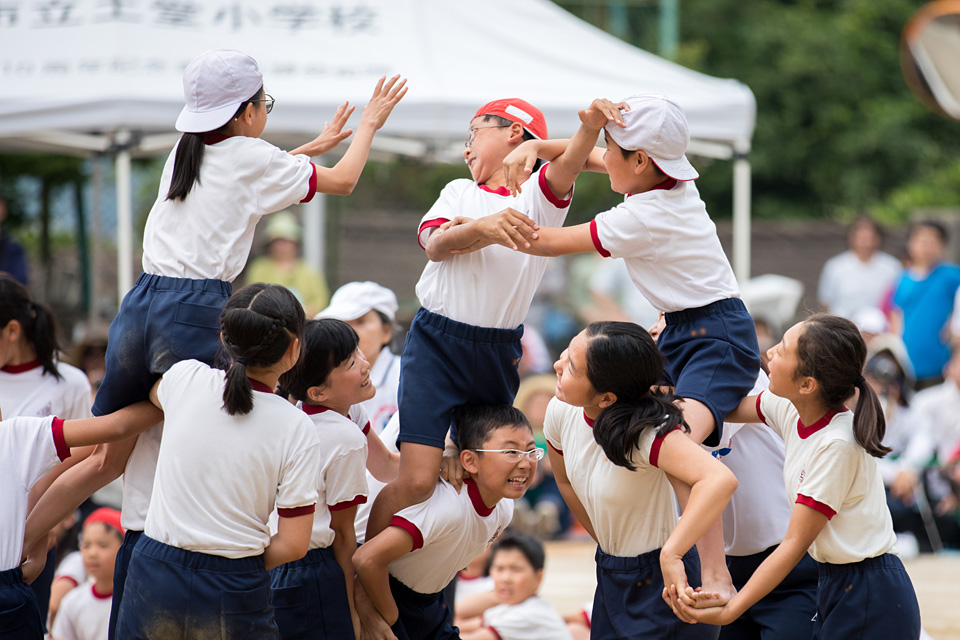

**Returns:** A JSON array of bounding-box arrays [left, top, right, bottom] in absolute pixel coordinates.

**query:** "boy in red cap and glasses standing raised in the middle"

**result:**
[[367, 98, 619, 540]]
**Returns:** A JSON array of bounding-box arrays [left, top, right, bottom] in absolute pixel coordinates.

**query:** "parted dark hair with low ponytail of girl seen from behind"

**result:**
[[220, 282, 305, 416]]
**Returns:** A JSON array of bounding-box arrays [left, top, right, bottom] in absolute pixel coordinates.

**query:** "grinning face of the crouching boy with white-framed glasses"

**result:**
[[461, 424, 537, 507]]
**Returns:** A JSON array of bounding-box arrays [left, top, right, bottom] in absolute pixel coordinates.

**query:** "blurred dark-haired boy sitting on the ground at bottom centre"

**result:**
[[457, 534, 571, 640]]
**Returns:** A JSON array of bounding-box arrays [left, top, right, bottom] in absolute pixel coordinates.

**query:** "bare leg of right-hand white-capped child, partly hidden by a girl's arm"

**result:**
[[674, 398, 737, 606]]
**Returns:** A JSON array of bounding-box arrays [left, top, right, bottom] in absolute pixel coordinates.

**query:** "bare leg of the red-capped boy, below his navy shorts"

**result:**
[[366, 442, 443, 540]]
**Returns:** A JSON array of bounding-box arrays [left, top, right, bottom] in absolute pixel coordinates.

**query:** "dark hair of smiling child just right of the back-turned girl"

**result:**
[[280, 318, 360, 401]]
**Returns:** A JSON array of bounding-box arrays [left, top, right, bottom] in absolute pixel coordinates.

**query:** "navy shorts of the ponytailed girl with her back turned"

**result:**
[[117, 535, 280, 640]]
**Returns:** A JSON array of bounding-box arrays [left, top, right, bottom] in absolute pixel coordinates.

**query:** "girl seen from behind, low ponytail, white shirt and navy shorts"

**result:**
[[116, 283, 320, 638]]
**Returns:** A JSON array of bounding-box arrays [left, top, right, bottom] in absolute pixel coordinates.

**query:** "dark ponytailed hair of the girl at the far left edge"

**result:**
[[0, 274, 63, 380]]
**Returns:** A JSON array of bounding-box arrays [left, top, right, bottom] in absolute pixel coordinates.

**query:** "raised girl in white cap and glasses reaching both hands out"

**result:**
[[93, 49, 406, 415]]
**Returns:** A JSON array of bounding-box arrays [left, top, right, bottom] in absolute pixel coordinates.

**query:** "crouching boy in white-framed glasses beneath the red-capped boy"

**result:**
[[353, 405, 543, 640]]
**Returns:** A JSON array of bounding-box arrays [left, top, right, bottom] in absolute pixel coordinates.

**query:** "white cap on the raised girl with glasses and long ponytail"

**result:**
[[176, 49, 263, 133]]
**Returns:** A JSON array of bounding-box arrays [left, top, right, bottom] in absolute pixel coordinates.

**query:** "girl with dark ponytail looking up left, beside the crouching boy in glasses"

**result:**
[[543, 322, 737, 640]]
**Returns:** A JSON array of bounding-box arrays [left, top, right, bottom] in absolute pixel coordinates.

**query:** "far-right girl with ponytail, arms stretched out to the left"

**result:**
[[678, 314, 920, 640]]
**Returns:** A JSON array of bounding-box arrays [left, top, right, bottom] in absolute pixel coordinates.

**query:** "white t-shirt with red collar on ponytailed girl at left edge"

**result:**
[[0, 360, 92, 420]]
